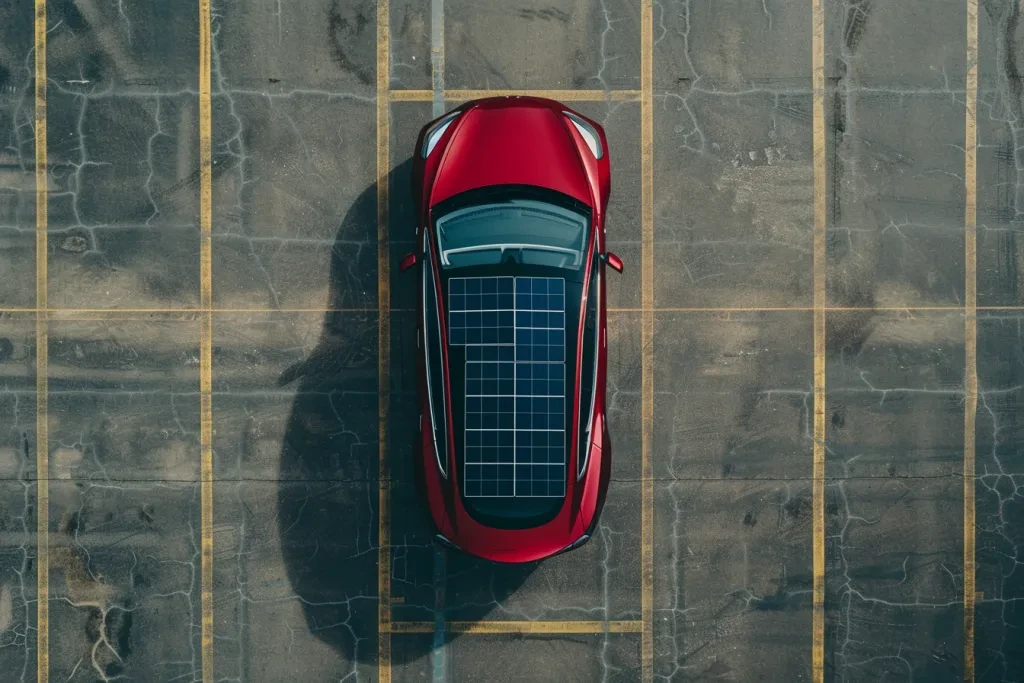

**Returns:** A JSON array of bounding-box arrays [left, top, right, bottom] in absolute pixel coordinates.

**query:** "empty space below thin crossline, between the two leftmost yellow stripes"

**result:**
[[36, 314, 201, 680]]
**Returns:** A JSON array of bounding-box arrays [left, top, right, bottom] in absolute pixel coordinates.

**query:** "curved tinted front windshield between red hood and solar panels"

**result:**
[[437, 200, 587, 269]]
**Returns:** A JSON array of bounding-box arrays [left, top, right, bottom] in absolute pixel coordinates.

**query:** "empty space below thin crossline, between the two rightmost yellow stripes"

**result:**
[[825, 311, 964, 680]]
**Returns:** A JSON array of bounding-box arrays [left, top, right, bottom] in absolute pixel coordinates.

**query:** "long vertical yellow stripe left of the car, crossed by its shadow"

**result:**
[[377, 0, 391, 683]]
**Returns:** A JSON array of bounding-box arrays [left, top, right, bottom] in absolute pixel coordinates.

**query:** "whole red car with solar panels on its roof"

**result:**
[[401, 97, 623, 562]]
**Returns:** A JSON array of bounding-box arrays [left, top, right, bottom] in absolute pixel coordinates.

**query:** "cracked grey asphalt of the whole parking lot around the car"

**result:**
[[0, 0, 1024, 683]]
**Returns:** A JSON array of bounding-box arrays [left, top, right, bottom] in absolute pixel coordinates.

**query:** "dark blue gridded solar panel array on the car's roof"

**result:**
[[449, 278, 565, 498]]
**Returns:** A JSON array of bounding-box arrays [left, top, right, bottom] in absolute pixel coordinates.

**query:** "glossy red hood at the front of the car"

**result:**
[[430, 100, 593, 206]]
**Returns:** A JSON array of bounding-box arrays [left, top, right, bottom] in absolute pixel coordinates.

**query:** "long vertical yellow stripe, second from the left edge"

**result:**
[[199, 0, 214, 683]]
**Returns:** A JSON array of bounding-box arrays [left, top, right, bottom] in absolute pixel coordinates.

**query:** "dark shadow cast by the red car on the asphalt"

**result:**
[[276, 160, 537, 665]]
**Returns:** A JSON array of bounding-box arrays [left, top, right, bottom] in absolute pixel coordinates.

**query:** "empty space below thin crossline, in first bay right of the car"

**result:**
[[653, 311, 813, 680]]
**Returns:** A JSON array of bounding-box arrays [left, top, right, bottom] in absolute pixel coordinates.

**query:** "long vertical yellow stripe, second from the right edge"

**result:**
[[811, 0, 826, 683]]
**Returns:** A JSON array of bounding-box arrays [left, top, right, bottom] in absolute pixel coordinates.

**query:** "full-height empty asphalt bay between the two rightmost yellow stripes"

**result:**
[[825, 2, 970, 680]]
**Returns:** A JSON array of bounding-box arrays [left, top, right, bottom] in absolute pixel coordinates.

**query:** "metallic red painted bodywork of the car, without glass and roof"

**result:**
[[413, 97, 611, 562]]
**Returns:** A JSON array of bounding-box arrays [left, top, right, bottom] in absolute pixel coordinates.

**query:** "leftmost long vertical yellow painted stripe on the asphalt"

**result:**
[[35, 0, 50, 683]]
